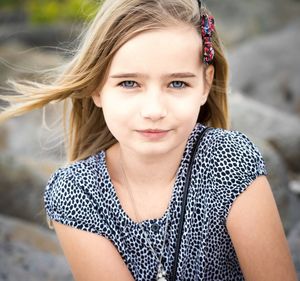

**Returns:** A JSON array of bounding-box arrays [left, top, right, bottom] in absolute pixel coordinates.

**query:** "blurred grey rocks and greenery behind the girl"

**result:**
[[0, 0, 300, 281]]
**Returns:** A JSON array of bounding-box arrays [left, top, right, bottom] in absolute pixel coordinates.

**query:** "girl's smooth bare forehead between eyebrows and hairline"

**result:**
[[110, 25, 202, 75]]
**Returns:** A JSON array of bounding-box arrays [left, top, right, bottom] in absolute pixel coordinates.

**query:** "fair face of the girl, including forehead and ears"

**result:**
[[93, 25, 214, 156]]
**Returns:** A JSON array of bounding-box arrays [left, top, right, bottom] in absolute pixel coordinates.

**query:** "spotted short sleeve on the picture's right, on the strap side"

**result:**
[[213, 130, 267, 220]]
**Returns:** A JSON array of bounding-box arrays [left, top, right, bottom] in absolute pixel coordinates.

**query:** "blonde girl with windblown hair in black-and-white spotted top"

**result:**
[[1, 0, 296, 281]]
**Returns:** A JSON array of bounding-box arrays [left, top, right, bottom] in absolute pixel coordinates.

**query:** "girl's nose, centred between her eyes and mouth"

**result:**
[[140, 90, 167, 121]]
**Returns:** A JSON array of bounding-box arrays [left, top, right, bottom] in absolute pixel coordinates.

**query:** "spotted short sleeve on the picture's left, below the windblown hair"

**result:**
[[44, 164, 106, 234]]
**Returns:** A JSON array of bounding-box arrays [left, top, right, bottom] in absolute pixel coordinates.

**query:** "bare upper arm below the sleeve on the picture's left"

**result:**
[[53, 221, 134, 281]]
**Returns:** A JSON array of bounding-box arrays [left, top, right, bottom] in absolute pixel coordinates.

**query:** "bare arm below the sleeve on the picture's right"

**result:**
[[226, 176, 297, 281]]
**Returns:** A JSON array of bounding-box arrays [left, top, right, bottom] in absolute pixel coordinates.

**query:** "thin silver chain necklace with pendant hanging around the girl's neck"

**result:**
[[120, 157, 170, 281]]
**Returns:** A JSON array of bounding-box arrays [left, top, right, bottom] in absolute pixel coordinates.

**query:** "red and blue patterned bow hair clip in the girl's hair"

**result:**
[[198, 0, 215, 65]]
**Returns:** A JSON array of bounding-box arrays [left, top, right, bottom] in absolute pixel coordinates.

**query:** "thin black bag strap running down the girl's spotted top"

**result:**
[[169, 127, 212, 281]]
